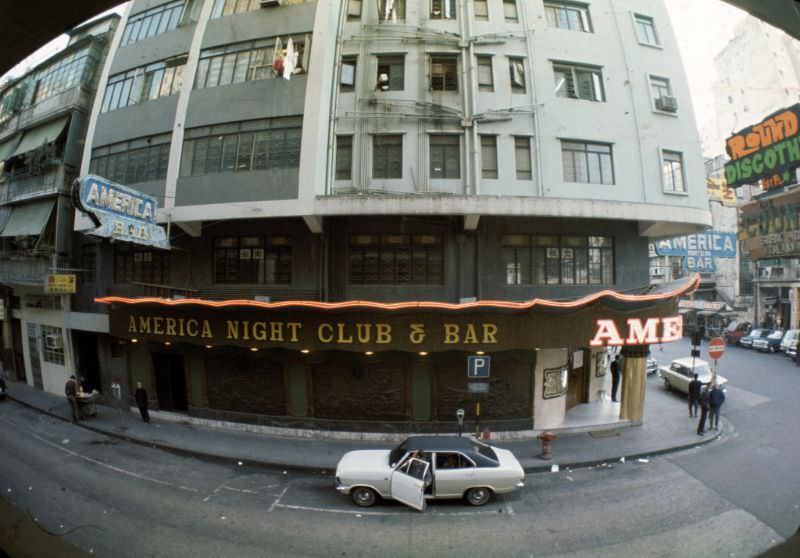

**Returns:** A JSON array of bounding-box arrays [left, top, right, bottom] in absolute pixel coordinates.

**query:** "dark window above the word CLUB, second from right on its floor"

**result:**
[[348, 234, 444, 285]]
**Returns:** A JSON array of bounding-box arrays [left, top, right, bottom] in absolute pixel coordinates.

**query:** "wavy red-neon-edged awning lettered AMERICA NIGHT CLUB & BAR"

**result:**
[[95, 275, 700, 353]]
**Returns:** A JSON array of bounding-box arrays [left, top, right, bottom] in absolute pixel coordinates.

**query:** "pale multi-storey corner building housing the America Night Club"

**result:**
[[67, 0, 710, 431]]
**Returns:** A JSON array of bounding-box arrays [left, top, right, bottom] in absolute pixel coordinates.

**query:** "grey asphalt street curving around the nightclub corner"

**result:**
[[0, 334, 800, 557]]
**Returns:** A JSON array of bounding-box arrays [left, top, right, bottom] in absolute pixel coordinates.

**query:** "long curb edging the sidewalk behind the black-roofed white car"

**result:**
[[9, 395, 728, 474]]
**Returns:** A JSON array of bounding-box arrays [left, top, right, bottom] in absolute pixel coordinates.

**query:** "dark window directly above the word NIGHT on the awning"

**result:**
[[213, 236, 292, 285]]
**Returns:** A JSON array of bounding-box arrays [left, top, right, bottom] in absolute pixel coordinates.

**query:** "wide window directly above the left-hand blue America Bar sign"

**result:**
[[89, 134, 171, 184]]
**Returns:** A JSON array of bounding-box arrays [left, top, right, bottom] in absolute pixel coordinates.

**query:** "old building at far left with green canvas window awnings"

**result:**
[[0, 16, 119, 392]]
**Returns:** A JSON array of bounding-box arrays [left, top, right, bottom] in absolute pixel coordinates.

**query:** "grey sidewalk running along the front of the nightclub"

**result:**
[[1, 378, 729, 473]]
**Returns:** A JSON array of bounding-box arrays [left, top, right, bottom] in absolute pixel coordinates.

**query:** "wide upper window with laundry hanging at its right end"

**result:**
[[194, 36, 308, 89]]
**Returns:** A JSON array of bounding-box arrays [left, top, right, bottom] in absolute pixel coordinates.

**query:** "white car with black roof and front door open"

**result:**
[[336, 436, 525, 511]]
